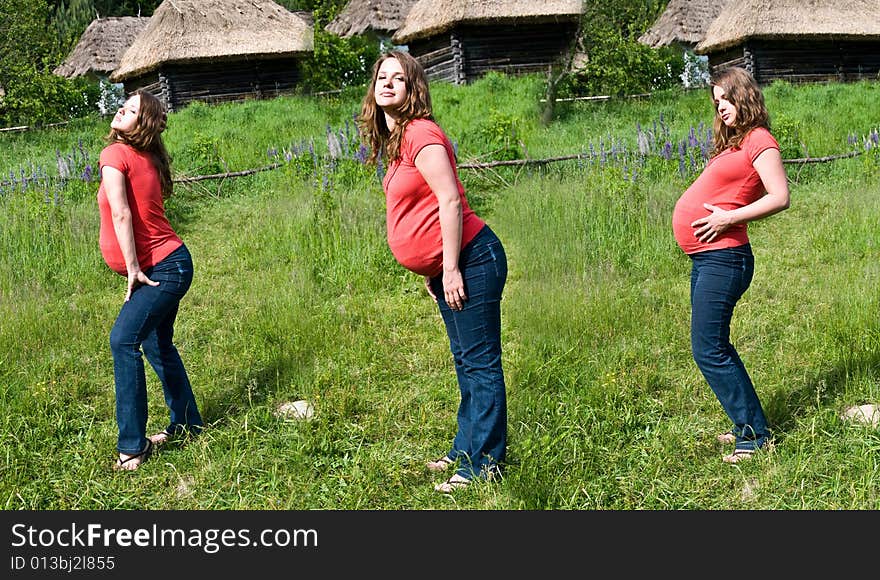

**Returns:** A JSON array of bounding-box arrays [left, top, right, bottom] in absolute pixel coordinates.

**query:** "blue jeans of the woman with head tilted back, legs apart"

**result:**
[[110, 245, 202, 455]]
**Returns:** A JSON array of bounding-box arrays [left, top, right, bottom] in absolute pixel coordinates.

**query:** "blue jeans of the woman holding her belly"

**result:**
[[690, 244, 769, 449]]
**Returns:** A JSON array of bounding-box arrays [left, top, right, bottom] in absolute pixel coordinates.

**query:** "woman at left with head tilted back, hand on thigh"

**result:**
[[98, 90, 202, 471]]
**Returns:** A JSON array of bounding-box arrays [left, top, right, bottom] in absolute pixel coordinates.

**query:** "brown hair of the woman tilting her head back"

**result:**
[[107, 89, 174, 199]]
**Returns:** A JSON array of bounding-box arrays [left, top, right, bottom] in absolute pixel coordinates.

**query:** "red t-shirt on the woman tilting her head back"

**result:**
[[98, 143, 183, 276]]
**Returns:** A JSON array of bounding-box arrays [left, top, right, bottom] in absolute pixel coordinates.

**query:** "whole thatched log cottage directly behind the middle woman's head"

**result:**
[[392, 0, 583, 84]]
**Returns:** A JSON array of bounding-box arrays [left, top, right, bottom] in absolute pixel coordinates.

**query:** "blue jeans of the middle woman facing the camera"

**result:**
[[430, 226, 507, 479]]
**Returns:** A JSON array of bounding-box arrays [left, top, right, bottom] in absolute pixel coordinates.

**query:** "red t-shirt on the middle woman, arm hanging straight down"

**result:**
[[382, 119, 485, 277]]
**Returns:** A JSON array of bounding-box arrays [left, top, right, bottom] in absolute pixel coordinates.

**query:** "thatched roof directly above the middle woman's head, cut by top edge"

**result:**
[[392, 0, 583, 44]]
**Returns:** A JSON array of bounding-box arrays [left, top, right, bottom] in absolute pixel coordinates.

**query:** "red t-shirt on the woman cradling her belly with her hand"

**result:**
[[672, 127, 779, 254]]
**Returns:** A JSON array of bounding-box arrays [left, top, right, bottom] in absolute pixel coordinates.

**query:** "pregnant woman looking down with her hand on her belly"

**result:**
[[672, 67, 790, 463]]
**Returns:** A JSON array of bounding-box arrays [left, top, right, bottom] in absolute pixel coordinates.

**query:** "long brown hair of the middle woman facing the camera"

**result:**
[[357, 50, 434, 163]]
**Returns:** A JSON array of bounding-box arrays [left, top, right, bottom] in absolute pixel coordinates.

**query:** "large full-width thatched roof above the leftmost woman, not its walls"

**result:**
[[110, 0, 315, 82]]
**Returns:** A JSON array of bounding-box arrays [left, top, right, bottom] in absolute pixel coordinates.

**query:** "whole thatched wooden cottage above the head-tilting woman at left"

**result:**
[[110, 0, 314, 111]]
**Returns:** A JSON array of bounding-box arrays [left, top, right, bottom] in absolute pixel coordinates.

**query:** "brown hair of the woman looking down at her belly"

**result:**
[[709, 66, 770, 155]]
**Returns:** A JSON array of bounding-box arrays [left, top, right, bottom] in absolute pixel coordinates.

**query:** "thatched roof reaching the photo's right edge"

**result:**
[[694, 0, 880, 54]]
